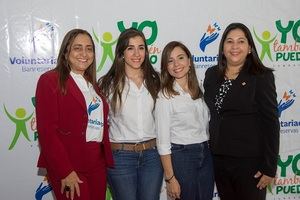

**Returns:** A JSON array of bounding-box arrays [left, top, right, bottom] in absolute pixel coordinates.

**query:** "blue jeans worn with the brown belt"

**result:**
[[108, 148, 163, 200]]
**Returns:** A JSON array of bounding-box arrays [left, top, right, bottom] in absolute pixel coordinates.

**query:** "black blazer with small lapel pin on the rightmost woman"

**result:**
[[204, 66, 280, 177]]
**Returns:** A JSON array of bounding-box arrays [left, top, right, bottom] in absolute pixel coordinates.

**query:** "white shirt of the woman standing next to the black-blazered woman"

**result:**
[[155, 81, 209, 155]]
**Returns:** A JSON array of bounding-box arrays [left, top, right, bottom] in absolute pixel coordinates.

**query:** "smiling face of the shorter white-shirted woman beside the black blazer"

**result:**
[[168, 47, 191, 81]]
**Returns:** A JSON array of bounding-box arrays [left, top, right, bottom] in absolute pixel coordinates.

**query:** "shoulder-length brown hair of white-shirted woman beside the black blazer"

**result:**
[[160, 41, 203, 99]]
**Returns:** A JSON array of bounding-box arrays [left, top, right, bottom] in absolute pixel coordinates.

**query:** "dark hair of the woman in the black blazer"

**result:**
[[218, 23, 273, 78]]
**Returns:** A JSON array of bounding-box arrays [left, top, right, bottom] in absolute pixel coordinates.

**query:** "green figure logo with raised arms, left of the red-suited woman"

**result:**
[[3, 97, 38, 150]]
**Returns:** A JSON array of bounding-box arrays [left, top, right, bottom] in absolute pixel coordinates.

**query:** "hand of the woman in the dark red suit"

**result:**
[[60, 171, 83, 200]]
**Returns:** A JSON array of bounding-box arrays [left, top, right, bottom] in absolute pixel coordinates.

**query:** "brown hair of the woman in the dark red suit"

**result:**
[[53, 29, 96, 94]]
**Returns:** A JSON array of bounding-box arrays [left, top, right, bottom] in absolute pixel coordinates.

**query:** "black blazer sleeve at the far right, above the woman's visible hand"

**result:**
[[256, 71, 280, 177]]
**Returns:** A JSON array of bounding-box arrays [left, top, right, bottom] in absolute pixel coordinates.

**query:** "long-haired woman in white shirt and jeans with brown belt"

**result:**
[[99, 28, 163, 200]]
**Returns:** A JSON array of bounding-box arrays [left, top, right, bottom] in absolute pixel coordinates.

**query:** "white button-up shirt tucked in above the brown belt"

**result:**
[[109, 78, 156, 143]]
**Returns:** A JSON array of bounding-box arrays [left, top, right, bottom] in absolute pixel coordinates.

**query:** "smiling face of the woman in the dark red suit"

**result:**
[[68, 34, 94, 75]]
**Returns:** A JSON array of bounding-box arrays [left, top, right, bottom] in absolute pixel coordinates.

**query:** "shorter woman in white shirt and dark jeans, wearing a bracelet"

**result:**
[[155, 41, 214, 200]]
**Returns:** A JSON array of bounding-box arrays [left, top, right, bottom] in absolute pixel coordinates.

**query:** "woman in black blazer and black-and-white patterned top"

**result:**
[[204, 23, 279, 200]]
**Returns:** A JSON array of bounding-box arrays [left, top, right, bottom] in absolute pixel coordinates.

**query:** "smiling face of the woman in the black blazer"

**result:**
[[223, 29, 251, 67]]
